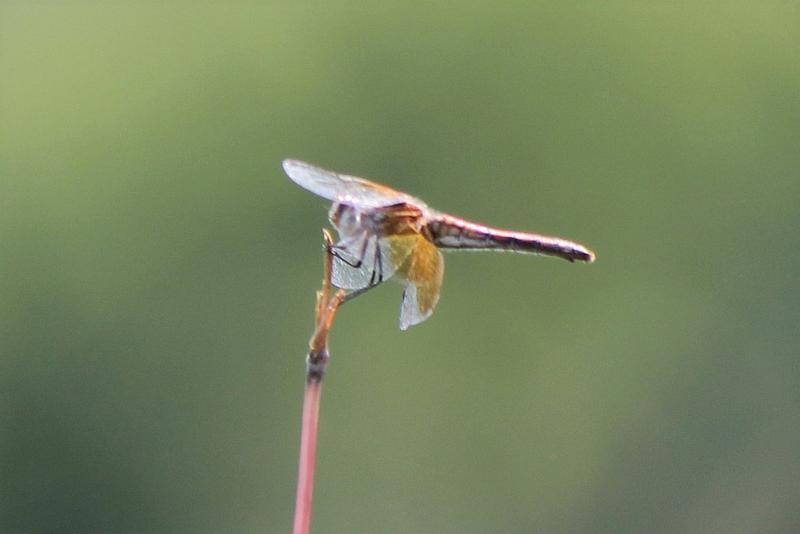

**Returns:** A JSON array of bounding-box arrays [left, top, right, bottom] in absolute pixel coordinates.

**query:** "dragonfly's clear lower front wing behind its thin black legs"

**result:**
[[331, 232, 405, 290]]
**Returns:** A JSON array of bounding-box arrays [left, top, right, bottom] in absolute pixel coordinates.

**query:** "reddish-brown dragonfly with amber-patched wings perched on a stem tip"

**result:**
[[283, 159, 595, 330]]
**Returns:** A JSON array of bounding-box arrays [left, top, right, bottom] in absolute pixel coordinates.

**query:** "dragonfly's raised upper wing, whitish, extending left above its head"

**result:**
[[283, 159, 425, 208]]
